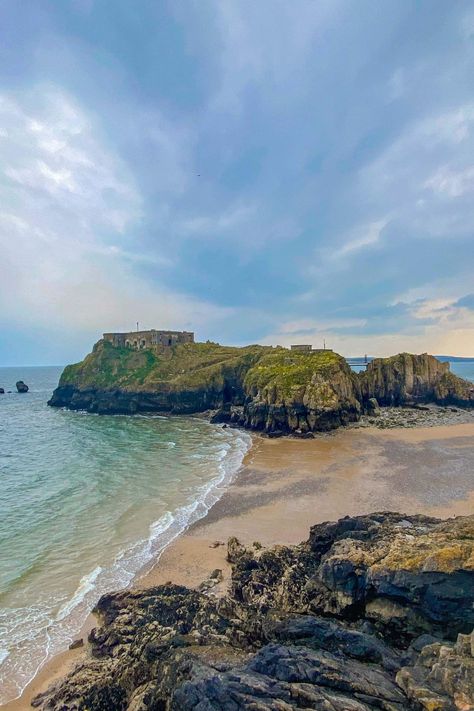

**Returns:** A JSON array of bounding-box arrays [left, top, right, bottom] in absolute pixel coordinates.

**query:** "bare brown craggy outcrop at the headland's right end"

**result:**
[[359, 353, 474, 407]]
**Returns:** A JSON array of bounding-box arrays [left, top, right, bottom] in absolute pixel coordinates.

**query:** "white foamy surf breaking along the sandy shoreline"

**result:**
[[0, 420, 251, 701]]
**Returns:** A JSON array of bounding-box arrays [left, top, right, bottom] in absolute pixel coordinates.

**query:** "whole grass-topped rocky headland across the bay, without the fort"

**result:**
[[49, 340, 474, 436]]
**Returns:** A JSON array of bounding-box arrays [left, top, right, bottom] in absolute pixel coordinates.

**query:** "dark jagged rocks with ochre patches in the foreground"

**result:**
[[33, 513, 474, 711]]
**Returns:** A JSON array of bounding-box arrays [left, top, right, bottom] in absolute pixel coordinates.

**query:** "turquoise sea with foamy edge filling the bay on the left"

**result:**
[[0, 367, 250, 703]]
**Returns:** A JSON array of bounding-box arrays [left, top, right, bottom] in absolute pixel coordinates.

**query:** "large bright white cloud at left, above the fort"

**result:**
[[0, 87, 231, 344]]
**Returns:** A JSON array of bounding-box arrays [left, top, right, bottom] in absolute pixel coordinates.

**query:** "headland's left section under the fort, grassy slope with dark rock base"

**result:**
[[48, 341, 268, 414]]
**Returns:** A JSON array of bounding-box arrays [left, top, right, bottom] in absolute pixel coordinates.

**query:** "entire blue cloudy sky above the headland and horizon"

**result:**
[[0, 0, 474, 365]]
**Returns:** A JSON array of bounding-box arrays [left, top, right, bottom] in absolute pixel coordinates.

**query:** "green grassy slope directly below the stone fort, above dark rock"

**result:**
[[60, 340, 269, 390]]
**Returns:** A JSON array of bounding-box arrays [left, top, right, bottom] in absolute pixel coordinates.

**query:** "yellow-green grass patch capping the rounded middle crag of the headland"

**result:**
[[245, 348, 348, 398]]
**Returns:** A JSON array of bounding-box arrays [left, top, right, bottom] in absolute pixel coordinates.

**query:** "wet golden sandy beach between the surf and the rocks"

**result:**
[[1, 424, 474, 711]]
